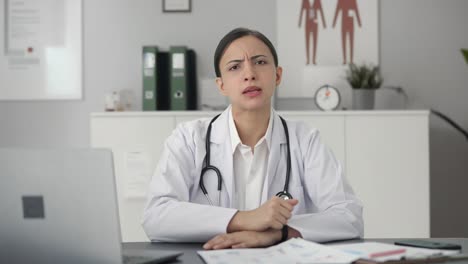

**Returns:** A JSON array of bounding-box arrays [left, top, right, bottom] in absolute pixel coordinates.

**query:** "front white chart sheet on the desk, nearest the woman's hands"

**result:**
[[198, 238, 359, 264]]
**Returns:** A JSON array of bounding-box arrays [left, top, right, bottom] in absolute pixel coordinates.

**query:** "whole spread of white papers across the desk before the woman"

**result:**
[[198, 238, 459, 264]]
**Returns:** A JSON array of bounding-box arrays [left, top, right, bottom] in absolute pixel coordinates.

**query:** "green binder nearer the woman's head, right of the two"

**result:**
[[169, 46, 197, 110]]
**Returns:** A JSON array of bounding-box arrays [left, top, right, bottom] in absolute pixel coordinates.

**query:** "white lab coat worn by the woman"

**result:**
[[142, 108, 363, 242]]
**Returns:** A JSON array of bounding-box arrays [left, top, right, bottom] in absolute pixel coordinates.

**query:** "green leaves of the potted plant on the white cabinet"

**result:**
[[346, 63, 383, 90]]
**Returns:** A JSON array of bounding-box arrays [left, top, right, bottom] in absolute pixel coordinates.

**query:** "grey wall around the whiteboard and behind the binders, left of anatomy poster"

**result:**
[[0, 0, 276, 147]]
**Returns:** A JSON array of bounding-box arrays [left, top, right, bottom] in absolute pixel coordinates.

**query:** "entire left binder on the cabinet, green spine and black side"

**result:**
[[142, 46, 169, 111]]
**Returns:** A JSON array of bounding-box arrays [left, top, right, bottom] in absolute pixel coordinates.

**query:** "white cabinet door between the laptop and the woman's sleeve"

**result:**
[[91, 116, 175, 242]]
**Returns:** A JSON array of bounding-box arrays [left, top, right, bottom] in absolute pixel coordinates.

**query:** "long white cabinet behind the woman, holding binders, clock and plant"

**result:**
[[90, 111, 430, 242]]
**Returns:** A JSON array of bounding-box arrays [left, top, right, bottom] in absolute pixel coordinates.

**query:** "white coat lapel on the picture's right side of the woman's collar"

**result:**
[[261, 111, 287, 204]]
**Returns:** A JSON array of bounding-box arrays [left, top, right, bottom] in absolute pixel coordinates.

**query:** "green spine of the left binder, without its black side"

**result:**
[[142, 46, 158, 111]]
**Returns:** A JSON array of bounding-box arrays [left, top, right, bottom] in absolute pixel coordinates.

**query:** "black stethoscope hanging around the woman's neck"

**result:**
[[200, 114, 293, 205]]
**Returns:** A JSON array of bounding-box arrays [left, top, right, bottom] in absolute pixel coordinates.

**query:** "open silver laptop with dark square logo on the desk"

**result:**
[[0, 149, 182, 264]]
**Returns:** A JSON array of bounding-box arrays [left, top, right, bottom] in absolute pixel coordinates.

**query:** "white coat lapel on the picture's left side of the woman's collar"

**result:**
[[210, 107, 233, 208]]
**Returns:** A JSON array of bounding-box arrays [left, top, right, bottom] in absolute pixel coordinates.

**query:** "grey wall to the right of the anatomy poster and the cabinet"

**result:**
[[380, 0, 468, 237]]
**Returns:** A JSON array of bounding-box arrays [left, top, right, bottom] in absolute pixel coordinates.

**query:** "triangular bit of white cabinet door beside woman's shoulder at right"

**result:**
[[283, 114, 346, 168]]
